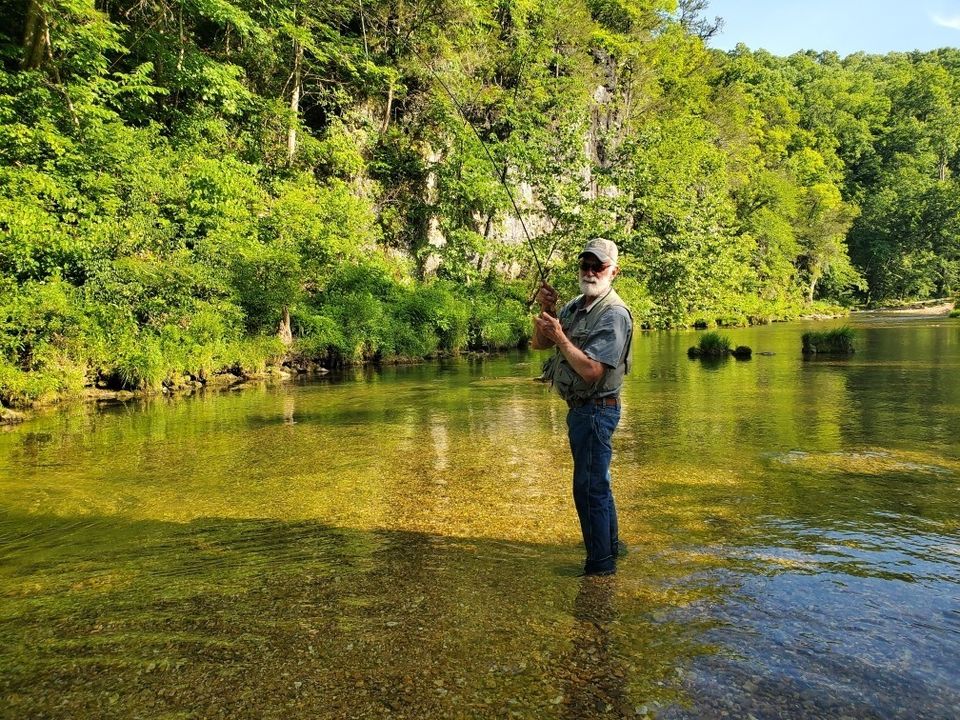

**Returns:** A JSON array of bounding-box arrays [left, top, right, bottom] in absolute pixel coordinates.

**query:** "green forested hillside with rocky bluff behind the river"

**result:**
[[0, 0, 960, 404]]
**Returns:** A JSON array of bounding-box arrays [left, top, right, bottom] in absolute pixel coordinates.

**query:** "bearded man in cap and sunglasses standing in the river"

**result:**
[[532, 238, 633, 575]]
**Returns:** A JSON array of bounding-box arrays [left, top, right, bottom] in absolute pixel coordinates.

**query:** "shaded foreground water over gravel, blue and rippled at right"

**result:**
[[0, 500, 960, 718]]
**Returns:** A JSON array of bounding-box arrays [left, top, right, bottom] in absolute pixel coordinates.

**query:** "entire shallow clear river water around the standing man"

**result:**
[[0, 315, 960, 718]]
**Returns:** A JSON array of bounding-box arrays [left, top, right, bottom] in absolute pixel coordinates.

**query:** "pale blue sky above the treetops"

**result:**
[[703, 0, 960, 56]]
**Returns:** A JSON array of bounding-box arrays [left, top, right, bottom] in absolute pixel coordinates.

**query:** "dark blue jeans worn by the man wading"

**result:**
[[567, 403, 620, 573]]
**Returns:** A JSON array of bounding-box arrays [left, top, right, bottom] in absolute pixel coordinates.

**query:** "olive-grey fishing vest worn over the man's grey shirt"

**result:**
[[542, 288, 633, 403]]
